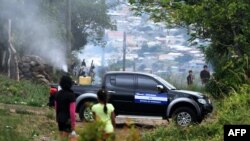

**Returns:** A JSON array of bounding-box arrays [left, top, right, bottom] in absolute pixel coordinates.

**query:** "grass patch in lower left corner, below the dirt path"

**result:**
[[0, 107, 57, 141]]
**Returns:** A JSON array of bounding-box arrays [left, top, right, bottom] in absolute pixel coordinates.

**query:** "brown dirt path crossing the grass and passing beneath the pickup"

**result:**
[[0, 103, 168, 141]]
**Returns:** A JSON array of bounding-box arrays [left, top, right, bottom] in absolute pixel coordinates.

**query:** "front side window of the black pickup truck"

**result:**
[[138, 75, 158, 91]]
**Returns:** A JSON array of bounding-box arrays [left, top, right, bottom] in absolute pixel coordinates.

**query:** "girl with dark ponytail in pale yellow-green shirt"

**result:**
[[91, 89, 115, 140]]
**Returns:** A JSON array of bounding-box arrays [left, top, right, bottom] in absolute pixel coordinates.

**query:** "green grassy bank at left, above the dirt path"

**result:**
[[0, 75, 49, 106]]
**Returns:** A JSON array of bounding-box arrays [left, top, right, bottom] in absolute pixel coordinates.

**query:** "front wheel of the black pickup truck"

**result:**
[[172, 107, 197, 126]]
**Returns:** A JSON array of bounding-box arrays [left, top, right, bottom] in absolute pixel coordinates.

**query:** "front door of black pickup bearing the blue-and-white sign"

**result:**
[[134, 75, 168, 116]]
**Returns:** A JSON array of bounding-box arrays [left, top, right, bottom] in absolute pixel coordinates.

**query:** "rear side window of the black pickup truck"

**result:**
[[116, 74, 134, 89]]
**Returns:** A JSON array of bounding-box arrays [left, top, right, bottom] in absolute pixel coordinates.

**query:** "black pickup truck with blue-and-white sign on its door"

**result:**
[[50, 72, 213, 126]]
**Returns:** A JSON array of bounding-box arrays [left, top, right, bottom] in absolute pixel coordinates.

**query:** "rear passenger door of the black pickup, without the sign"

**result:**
[[106, 74, 135, 114]]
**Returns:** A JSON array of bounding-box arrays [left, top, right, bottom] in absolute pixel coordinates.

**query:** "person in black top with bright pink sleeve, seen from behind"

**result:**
[[55, 75, 76, 139]]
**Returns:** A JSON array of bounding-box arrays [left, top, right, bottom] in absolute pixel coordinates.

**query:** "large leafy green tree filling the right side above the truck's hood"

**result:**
[[129, 0, 250, 95]]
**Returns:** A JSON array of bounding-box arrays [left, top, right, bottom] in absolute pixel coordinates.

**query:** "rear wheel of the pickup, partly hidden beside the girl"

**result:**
[[79, 101, 96, 122]]
